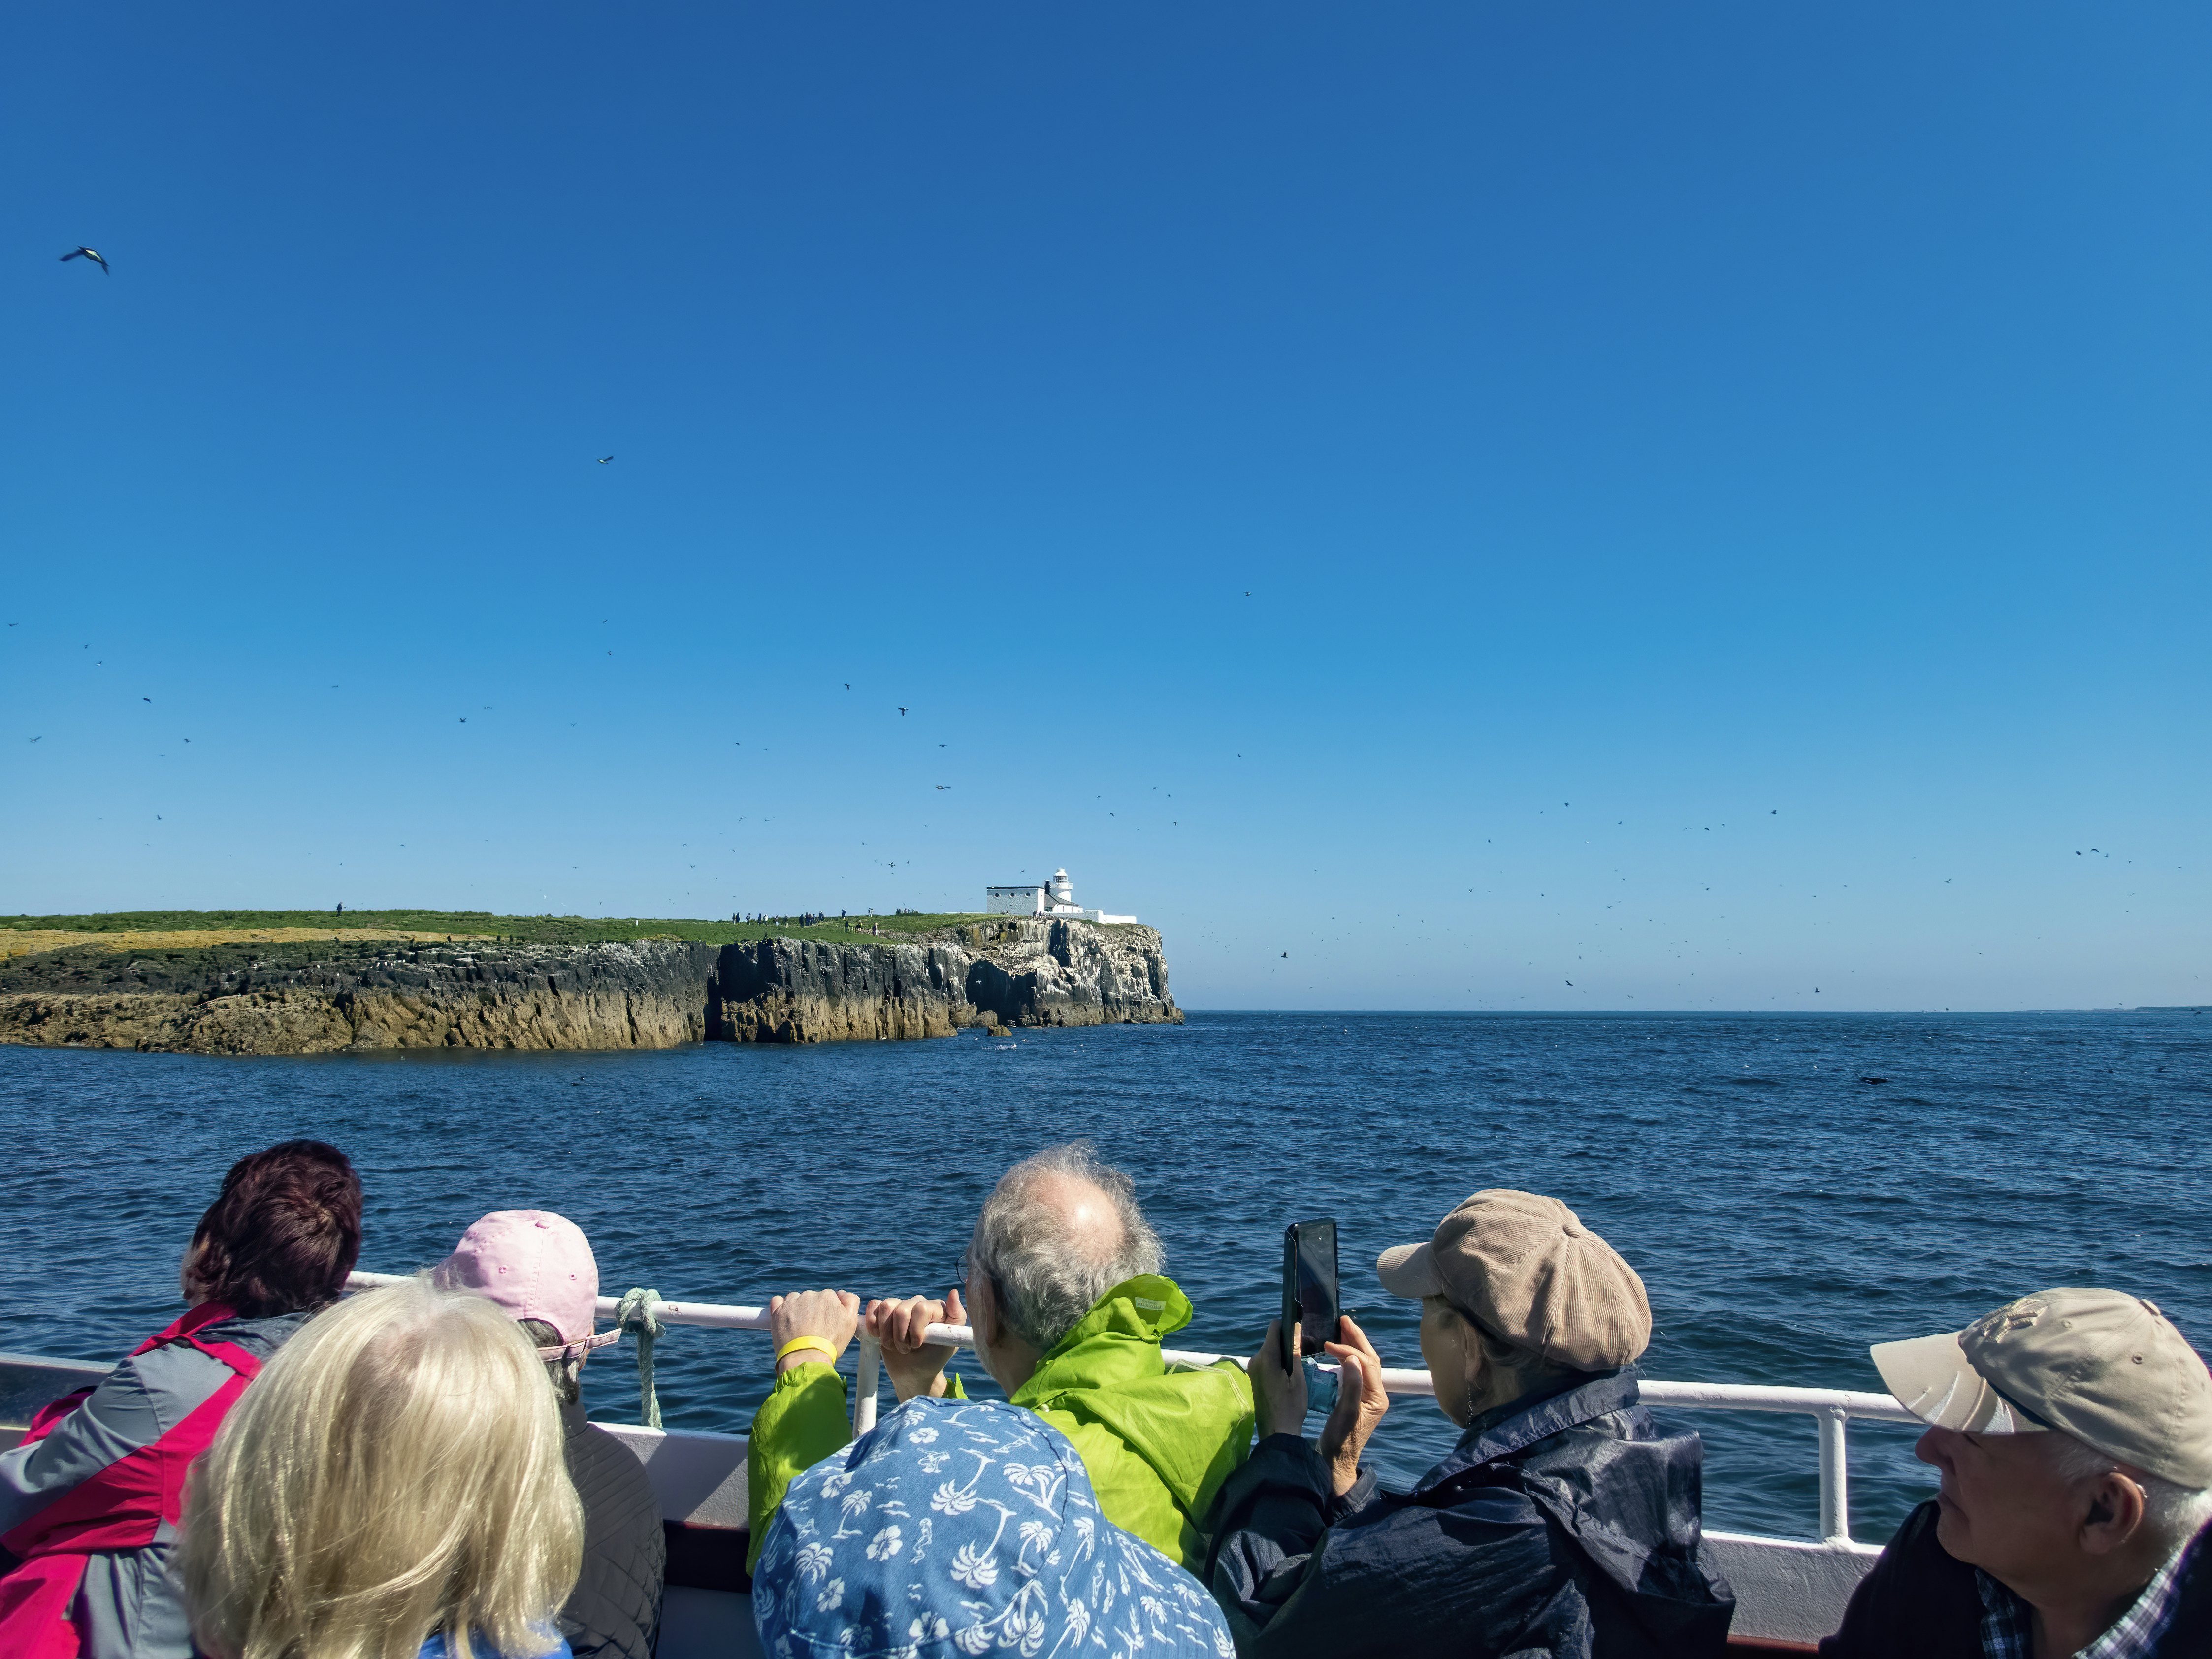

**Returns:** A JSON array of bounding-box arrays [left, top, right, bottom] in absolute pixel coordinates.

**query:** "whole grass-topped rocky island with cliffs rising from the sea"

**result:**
[[0, 905, 1183, 1055]]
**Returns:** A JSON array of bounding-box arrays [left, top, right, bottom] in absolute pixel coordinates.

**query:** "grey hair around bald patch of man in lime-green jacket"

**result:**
[[969, 1141, 1168, 1354]]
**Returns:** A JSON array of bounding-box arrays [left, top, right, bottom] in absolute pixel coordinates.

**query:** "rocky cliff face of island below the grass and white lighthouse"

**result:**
[[0, 918, 1183, 1055]]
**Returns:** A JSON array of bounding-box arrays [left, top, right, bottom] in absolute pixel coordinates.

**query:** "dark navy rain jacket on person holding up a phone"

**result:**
[[1208, 1371, 1736, 1659]]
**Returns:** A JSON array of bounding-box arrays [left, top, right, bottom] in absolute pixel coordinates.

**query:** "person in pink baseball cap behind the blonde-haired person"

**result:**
[[429, 1210, 668, 1659]]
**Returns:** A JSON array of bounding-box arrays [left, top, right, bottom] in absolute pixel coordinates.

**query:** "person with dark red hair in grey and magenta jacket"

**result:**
[[0, 1141, 360, 1659]]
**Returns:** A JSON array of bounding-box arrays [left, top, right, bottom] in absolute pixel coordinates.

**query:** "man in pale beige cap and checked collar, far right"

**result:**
[[1821, 1290, 2212, 1659]]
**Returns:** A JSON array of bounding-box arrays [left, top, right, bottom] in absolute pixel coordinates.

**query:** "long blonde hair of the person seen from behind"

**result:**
[[181, 1278, 584, 1659]]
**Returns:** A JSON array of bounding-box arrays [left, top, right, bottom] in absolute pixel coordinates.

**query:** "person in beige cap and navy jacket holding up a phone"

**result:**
[[1208, 1188, 1734, 1659]]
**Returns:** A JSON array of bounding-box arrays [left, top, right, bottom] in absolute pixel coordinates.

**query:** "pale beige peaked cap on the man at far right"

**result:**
[[1869, 1290, 2212, 1487]]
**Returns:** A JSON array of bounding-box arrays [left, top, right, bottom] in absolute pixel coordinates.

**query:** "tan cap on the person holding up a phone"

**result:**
[[1376, 1188, 1653, 1371]]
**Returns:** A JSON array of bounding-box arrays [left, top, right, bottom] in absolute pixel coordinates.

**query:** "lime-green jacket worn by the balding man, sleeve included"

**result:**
[[746, 1274, 1252, 1570]]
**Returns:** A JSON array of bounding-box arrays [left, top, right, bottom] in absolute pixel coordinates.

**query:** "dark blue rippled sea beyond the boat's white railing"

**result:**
[[0, 1013, 2212, 1542]]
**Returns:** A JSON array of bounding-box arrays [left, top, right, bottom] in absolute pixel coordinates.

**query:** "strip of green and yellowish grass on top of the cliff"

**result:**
[[0, 909, 984, 944]]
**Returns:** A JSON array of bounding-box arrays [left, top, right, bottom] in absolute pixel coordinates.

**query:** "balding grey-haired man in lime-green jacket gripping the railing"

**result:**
[[748, 1141, 1252, 1564]]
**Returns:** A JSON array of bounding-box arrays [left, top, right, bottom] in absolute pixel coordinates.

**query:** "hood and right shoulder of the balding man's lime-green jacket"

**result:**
[[1013, 1274, 1252, 1561]]
